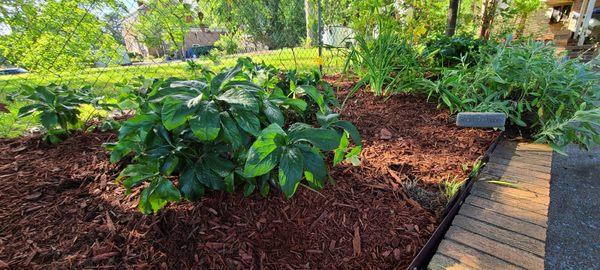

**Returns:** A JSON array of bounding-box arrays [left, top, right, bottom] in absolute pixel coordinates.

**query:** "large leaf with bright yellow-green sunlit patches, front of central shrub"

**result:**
[[244, 124, 286, 177]]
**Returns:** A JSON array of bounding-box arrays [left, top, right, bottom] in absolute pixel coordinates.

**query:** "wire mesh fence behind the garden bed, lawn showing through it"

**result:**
[[0, 0, 349, 137]]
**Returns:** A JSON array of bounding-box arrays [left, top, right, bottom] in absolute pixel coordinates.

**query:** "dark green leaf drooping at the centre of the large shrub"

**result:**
[[189, 102, 221, 141]]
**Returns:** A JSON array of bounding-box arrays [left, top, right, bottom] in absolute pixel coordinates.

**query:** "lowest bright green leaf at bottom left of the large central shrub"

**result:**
[[138, 177, 181, 214]]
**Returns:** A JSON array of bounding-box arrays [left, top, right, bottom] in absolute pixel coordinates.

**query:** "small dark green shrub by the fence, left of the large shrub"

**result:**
[[19, 84, 113, 143]]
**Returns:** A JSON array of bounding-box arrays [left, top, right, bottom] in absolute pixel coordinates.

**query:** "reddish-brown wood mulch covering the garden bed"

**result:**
[[0, 77, 498, 269]]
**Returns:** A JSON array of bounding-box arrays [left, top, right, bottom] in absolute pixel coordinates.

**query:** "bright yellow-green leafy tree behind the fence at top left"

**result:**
[[0, 0, 119, 72]]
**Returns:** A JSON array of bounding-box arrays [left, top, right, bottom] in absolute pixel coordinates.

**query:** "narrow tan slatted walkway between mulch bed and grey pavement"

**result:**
[[428, 142, 552, 269]]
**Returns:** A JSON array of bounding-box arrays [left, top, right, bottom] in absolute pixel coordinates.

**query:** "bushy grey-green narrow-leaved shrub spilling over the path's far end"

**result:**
[[425, 41, 600, 151]]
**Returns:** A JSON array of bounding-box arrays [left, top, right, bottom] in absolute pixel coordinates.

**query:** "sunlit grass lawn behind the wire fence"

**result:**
[[0, 48, 344, 137]]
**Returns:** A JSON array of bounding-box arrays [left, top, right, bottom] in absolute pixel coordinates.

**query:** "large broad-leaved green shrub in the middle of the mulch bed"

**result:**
[[107, 58, 361, 213]]
